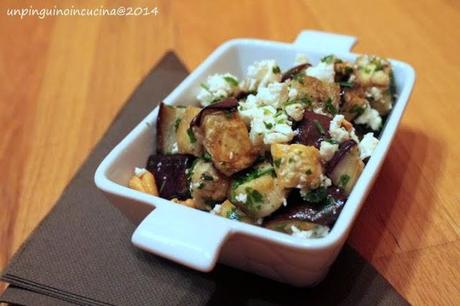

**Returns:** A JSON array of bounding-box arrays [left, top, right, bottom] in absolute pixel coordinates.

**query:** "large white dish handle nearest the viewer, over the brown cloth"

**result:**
[[131, 205, 230, 272]]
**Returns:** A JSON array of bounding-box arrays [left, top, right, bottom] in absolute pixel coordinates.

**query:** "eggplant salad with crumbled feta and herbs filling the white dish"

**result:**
[[128, 54, 396, 238]]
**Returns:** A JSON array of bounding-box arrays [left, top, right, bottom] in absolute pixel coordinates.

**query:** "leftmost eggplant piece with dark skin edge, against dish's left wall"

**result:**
[[157, 103, 185, 154]]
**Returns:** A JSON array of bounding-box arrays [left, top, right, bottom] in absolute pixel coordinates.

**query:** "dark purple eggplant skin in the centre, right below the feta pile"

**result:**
[[294, 110, 331, 148]]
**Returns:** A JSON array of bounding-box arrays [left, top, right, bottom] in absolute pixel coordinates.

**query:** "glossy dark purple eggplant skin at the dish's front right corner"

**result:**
[[263, 186, 347, 228]]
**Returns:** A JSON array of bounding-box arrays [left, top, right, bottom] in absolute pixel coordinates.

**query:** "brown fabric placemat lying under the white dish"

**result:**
[[0, 53, 407, 305]]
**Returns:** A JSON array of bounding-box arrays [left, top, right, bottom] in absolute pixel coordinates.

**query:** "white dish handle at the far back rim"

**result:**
[[293, 30, 357, 53]]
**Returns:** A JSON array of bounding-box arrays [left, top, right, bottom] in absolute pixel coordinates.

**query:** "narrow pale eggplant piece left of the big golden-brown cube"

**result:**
[[176, 106, 203, 157]]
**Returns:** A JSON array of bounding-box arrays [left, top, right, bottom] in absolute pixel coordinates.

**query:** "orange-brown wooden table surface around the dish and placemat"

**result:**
[[0, 0, 460, 305]]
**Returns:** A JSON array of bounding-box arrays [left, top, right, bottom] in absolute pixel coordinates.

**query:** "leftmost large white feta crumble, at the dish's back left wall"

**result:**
[[196, 73, 239, 106]]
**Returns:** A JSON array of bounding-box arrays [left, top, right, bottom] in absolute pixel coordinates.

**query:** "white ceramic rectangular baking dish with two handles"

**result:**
[[95, 31, 415, 286]]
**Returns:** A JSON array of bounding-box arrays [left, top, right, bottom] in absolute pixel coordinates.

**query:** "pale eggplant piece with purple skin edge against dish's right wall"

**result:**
[[326, 140, 364, 195]]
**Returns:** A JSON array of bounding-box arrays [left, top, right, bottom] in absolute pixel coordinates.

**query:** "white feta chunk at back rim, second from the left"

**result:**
[[241, 60, 281, 91]]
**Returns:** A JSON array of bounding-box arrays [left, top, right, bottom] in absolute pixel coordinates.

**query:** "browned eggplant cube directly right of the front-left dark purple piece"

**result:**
[[188, 158, 230, 209]]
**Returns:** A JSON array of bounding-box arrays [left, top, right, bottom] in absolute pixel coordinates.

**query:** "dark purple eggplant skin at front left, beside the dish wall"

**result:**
[[146, 154, 195, 200]]
